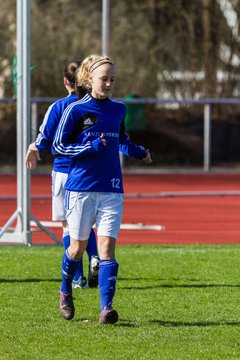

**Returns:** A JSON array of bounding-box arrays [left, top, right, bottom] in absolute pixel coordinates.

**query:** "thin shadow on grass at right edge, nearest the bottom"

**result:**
[[150, 320, 240, 327]]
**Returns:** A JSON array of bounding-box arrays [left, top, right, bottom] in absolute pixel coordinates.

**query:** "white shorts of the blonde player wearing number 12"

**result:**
[[65, 191, 123, 240]]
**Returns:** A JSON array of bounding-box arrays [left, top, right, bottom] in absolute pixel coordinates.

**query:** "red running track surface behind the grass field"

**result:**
[[0, 174, 240, 244]]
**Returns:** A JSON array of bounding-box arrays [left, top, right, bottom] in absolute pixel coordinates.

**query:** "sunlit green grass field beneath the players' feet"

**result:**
[[0, 245, 240, 360]]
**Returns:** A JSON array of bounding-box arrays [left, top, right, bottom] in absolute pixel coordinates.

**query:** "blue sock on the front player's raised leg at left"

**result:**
[[61, 250, 79, 293]]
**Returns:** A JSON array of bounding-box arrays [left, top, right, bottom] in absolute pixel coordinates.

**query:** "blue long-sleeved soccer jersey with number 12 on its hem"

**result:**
[[53, 96, 146, 193]]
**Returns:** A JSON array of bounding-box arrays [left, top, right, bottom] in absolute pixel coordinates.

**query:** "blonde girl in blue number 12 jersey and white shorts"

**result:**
[[53, 55, 152, 324]]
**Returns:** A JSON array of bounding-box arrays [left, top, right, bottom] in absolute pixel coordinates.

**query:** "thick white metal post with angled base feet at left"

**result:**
[[0, 0, 62, 246]]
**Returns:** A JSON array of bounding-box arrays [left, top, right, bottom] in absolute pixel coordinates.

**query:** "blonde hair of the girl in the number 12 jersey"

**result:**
[[76, 54, 114, 92]]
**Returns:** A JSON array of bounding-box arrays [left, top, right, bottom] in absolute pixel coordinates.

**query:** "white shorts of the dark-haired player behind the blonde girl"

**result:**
[[52, 170, 68, 221]]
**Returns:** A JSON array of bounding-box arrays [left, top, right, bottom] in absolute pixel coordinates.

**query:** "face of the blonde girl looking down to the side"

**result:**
[[90, 64, 115, 99]]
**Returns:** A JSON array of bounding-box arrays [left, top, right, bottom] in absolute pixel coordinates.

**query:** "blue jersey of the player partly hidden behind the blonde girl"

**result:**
[[35, 93, 89, 173]]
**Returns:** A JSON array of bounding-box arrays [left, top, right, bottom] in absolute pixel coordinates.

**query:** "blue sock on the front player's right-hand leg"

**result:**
[[99, 259, 118, 311]]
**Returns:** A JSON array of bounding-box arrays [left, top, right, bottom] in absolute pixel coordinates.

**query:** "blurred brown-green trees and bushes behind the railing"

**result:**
[[0, 0, 239, 97]]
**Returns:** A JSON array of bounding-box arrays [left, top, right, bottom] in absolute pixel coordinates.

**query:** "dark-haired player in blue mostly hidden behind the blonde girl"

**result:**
[[26, 61, 99, 288]]
